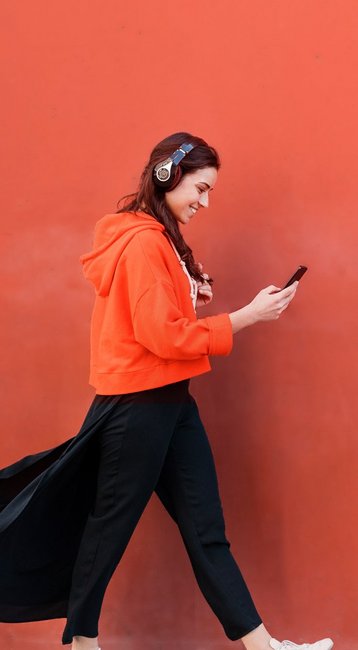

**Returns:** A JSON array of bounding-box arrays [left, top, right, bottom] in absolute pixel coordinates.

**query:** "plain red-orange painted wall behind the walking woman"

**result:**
[[0, 0, 358, 650]]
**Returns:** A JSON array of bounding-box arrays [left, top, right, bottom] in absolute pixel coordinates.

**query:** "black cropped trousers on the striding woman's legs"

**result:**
[[62, 379, 262, 644]]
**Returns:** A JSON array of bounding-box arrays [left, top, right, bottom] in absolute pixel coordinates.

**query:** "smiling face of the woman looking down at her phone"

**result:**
[[165, 167, 218, 224]]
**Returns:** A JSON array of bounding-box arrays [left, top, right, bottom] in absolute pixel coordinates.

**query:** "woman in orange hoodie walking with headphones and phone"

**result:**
[[0, 133, 333, 650]]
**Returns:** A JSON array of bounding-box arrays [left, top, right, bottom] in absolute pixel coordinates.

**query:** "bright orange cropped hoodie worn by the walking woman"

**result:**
[[80, 212, 233, 395]]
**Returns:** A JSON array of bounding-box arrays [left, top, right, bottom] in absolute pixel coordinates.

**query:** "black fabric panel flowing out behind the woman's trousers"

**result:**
[[0, 397, 117, 623]]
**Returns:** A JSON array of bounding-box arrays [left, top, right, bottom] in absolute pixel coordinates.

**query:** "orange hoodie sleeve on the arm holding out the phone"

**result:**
[[126, 230, 233, 360]]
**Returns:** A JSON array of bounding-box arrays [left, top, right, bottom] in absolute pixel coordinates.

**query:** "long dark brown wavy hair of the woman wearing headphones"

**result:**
[[116, 132, 220, 285]]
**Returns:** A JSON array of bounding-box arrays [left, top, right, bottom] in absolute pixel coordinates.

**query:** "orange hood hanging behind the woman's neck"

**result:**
[[80, 212, 165, 296]]
